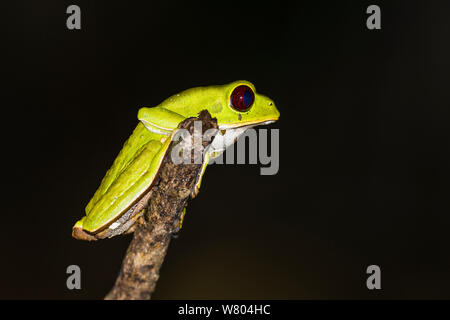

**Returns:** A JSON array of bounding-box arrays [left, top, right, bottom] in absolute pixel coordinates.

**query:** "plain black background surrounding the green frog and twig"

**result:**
[[0, 1, 450, 299]]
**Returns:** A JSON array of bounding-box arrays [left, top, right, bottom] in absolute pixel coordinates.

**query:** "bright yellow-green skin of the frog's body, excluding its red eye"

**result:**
[[72, 80, 280, 240]]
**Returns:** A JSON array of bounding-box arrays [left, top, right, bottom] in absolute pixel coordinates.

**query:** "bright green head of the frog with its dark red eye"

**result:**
[[204, 80, 280, 130]]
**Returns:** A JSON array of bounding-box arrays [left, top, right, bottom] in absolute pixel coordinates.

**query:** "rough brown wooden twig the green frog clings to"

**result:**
[[105, 111, 217, 300]]
